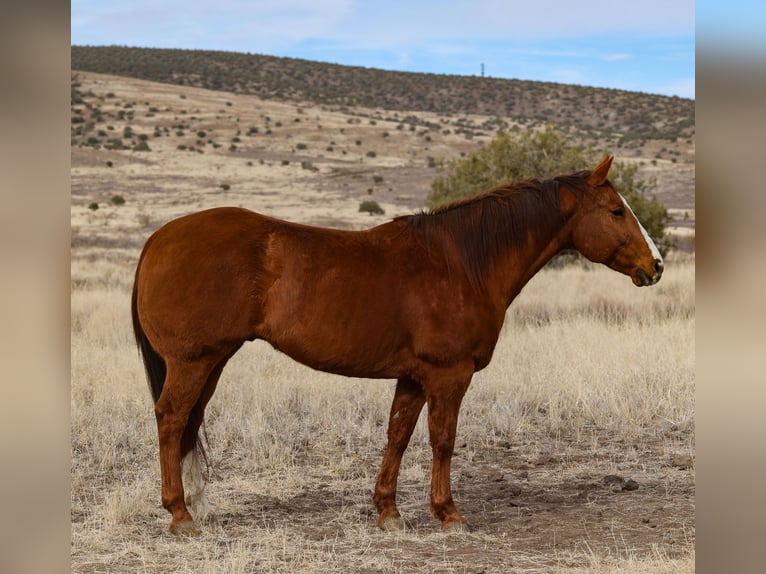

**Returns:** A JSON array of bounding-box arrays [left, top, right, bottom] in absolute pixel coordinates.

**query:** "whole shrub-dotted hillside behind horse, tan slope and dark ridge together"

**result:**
[[72, 51, 695, 250]]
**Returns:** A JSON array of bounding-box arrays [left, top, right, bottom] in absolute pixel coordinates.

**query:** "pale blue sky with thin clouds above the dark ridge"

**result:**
[[71, 0, 695, 98]]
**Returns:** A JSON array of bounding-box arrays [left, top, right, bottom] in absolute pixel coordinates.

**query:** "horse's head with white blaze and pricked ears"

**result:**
[[561, 156, 664, 287]]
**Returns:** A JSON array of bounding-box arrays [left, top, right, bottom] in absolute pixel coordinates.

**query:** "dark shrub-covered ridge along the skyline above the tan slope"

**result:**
[[72, 46, 694, 145]]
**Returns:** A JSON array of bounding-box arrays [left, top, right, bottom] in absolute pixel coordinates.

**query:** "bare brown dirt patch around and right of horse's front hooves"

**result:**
[[196, 433, 694, 572]]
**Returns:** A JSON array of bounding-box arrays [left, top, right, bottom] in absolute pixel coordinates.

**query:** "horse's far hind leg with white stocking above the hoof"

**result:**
[[181, 357, 234, 522]]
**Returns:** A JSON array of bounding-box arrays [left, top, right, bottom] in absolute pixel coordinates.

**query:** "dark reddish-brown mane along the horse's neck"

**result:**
[[396, 171, 591, 290]]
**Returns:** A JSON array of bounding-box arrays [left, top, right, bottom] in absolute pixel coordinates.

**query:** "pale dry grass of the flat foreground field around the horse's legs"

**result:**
[[71, 254, 695, 572]]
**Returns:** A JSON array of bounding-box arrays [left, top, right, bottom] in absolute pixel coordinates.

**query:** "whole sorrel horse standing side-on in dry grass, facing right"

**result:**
[[132, 156, 663, 533]]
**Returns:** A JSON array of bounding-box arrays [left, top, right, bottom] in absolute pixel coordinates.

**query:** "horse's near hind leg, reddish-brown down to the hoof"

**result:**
[[154, 360, 216, 534]]
